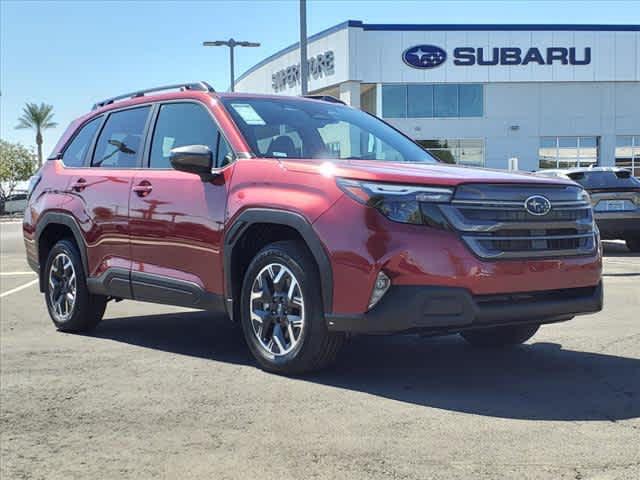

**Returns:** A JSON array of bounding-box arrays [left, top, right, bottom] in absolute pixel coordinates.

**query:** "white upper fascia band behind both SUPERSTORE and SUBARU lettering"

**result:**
[[236, 26, 640, 95]]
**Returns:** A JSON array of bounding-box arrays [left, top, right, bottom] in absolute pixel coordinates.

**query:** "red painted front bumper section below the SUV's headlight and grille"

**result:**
[[313, 195, 602, 315]]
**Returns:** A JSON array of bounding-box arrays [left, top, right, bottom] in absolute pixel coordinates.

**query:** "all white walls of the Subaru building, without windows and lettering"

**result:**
[[236, 25, 640, 170]]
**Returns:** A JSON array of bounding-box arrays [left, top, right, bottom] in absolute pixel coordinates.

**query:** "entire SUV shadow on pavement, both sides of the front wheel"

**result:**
[[87, 312, 640, 422]]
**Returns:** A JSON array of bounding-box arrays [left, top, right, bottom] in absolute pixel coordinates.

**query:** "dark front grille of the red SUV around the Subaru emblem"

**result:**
[[440, 185, 596, 259]]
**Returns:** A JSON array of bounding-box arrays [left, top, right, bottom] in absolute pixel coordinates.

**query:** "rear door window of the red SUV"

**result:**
[[91, 107, 150, 168]]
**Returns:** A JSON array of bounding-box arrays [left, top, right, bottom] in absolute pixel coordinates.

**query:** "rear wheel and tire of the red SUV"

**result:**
[[43, 239, 107, 332]]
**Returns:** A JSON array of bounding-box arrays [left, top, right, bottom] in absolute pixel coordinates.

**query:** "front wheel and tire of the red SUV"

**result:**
[[240, 241, 345, 375]]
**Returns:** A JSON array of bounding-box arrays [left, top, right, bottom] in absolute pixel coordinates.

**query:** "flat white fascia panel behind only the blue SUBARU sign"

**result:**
[[351, 28, 640, 83]]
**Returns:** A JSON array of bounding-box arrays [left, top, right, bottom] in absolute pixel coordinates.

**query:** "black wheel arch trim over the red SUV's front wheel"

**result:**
[[223, 208, 333, 320]]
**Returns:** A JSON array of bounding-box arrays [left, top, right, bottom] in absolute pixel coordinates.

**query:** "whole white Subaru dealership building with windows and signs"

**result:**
[[235, 20, 640, 175]]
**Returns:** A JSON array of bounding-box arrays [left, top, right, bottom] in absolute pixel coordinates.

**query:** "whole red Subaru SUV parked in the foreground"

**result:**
[[24, 82, 602, 374]]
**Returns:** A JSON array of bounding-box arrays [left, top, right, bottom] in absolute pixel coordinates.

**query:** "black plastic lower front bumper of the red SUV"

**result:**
[[326, 283, 602, 333]]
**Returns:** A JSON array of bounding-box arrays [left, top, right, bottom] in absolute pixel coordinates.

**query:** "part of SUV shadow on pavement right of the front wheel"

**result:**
[[313, 327, 640, 421]]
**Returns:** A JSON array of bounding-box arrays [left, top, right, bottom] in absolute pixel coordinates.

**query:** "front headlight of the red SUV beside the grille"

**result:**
[[337, 178, 453, 224]]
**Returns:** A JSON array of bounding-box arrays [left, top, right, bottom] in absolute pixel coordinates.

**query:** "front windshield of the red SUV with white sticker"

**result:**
[[222, 97, 437, 163]]
